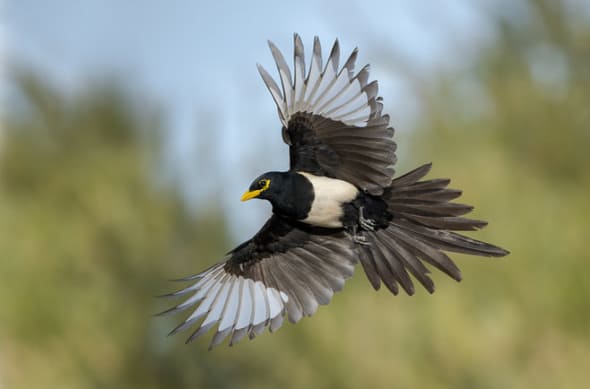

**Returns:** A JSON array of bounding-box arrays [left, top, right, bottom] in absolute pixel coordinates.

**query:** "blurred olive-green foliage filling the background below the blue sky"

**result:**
[[0, 1, 590, 389]]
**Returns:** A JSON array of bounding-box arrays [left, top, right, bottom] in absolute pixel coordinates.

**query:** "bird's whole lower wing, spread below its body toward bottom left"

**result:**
[[162, 215, 356, 347]]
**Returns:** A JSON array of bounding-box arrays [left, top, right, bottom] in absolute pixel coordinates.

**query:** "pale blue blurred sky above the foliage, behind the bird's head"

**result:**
[[0, 0, 500, 240]]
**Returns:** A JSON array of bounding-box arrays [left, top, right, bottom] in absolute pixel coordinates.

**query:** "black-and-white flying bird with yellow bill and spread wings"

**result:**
[[162, 34, 508, 348]]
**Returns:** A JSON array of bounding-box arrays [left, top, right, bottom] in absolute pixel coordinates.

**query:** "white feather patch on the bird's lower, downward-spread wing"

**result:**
[[162, 263, 289, 347]]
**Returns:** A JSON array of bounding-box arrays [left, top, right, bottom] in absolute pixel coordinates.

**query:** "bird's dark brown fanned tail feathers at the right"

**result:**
[[359, 164, 508, 295]]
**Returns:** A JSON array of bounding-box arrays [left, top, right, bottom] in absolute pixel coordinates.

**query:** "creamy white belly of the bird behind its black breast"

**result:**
[[298, 172, 358, 228]]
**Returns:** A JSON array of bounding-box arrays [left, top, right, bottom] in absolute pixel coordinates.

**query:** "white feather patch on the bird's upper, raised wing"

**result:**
[[258, 34, 380, 127]]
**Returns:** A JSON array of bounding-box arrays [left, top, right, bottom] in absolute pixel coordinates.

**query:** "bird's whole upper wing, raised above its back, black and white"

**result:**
[[258, 34, 396, 194]]
